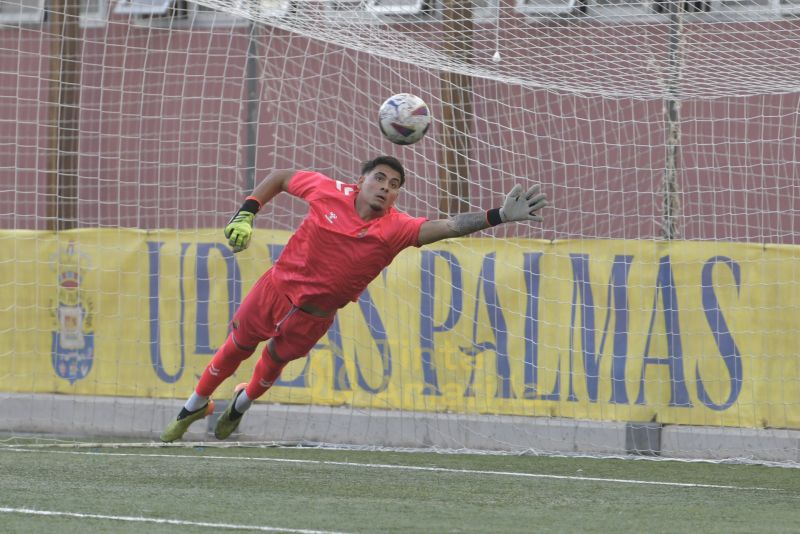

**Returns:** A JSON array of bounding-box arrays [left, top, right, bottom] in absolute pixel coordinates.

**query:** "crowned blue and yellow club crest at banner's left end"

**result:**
[[50, 241, 94, 384]]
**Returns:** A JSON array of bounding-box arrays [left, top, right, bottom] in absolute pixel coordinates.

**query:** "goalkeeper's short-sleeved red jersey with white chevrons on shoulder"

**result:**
[[272, 171, 427, 311]]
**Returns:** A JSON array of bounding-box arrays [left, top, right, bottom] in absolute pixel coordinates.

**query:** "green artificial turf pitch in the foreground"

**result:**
[[0, 445, 800, 533]]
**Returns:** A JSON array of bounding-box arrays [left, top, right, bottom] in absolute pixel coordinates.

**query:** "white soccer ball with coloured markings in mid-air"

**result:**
[[378, 93, 431, 145]]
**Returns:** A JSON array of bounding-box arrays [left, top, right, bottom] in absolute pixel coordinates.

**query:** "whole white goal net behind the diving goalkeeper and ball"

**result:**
[[0, 0, 800, 463]]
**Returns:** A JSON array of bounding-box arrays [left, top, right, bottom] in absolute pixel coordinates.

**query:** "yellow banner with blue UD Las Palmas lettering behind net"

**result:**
[[0, 229, 800, 429]]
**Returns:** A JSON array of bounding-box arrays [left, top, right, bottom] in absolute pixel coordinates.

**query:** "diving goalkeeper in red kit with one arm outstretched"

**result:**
[[161, 156, 548, 442]]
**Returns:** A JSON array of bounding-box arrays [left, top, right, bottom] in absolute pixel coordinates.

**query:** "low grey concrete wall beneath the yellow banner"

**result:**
[[0, 393, 800, 464]]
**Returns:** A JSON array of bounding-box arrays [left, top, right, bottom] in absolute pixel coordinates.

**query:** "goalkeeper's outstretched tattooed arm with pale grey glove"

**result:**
[[419, 184, 548, 245]]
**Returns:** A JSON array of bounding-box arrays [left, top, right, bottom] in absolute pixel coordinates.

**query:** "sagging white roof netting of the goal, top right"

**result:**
[[201, 0, 800, 98]]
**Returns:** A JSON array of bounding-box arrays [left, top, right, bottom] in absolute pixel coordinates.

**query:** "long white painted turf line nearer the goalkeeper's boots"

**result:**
[[6, 448, 780, 491]]
